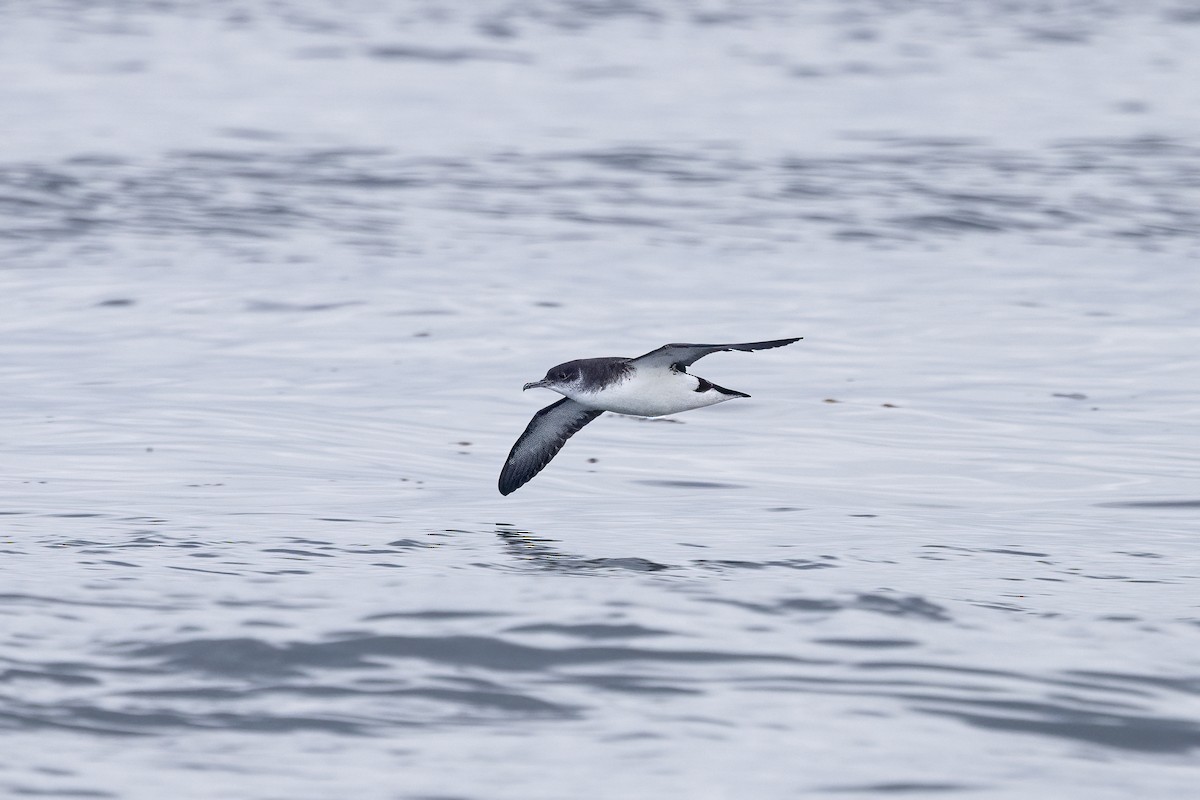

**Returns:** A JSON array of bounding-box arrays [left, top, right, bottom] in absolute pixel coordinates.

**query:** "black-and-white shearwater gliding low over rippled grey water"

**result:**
[[499, 336, 804, 494]]
